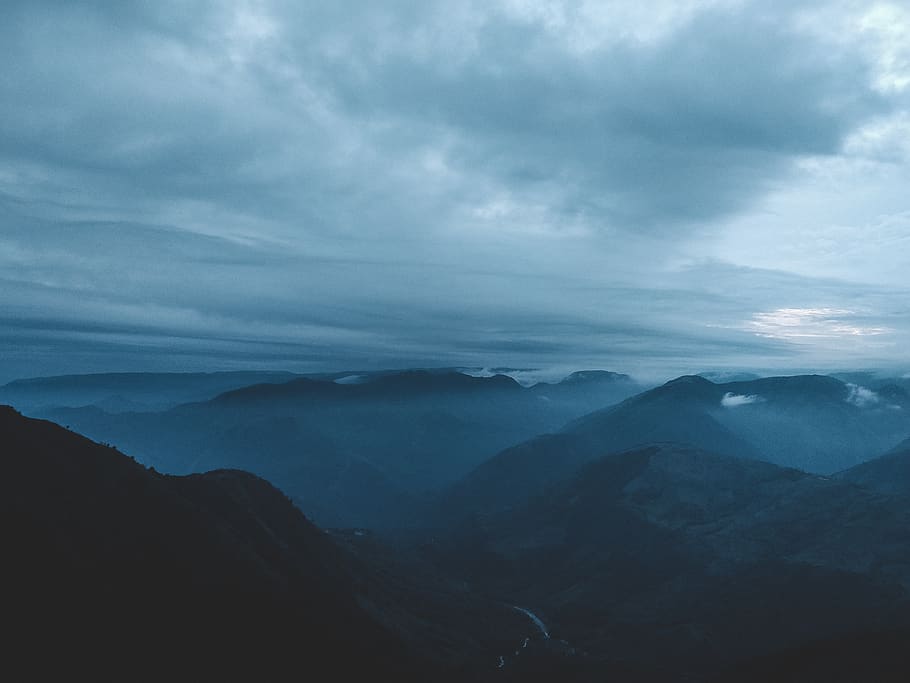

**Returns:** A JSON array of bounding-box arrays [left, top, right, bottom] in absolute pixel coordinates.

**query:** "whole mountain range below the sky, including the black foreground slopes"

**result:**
[[0, 370, 910, 683]]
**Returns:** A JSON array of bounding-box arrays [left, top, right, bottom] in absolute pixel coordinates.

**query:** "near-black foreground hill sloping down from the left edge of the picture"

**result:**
[[0, 408, 436, 681]]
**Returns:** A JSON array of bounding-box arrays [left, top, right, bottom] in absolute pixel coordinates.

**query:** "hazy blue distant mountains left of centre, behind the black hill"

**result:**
[[28, 370, 640, 528]]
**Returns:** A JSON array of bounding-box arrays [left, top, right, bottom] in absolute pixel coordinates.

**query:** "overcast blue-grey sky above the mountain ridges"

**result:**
[[0, 0, 910, 381]]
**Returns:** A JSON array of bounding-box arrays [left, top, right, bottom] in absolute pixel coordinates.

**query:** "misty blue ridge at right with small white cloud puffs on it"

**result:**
[[443, 375, 910, 511]]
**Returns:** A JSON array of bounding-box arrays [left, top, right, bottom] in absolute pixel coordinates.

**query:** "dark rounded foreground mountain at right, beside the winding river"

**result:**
[[424, 444, 910, 681]]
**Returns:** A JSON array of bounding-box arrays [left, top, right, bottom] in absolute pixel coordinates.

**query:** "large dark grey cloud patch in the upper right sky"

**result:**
[[312, 1, 886, 229]]
